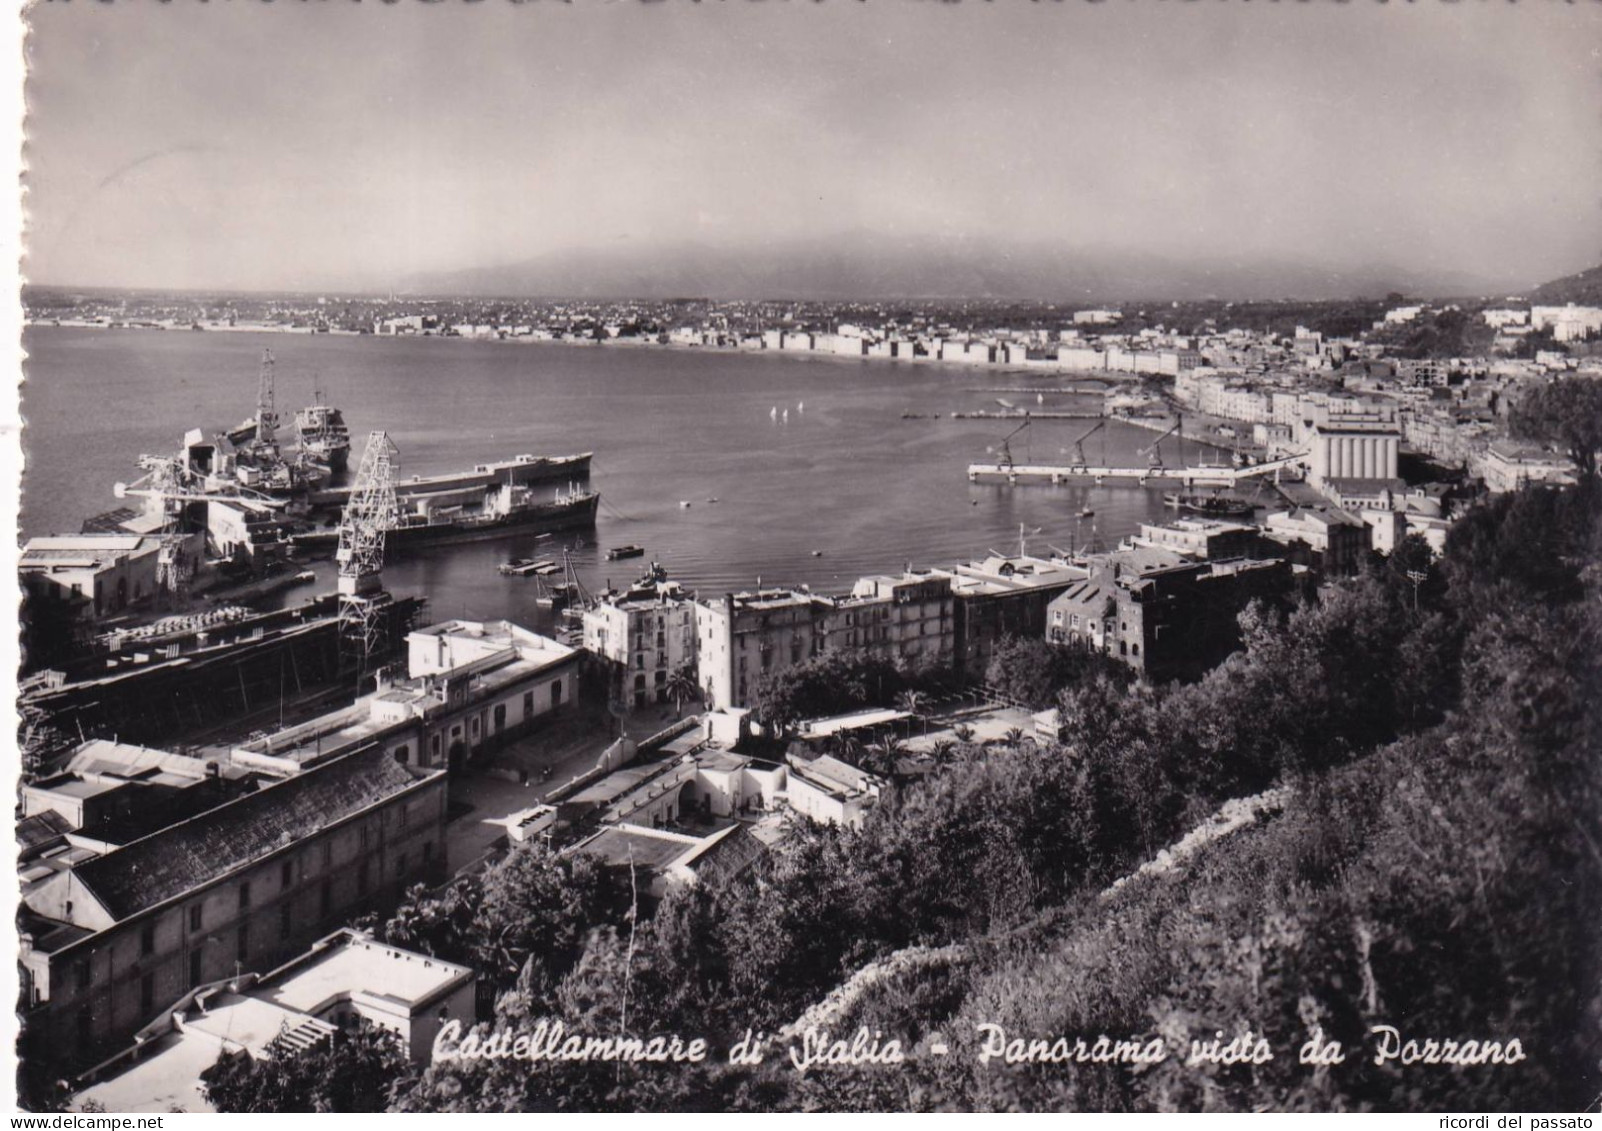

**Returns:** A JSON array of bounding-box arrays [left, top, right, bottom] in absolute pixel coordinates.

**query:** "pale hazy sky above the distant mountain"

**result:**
[[26, 0, 1602, 288]]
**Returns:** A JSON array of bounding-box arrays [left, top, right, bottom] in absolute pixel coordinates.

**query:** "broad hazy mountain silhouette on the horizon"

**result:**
[[407, 234, 1506, 303]]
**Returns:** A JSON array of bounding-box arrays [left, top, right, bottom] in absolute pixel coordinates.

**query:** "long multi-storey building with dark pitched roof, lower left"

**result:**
[[21, 743, 445, 1069]]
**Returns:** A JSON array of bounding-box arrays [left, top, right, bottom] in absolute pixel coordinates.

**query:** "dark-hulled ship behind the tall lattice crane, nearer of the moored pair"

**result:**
[[293, 484, 601, 551]]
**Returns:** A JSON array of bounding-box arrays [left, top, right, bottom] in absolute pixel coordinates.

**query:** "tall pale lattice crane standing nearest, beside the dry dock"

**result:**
[[335, 433, 399, 668]]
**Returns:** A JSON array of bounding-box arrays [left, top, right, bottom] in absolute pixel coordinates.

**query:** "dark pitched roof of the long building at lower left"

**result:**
[[75, 747, 442, 920]]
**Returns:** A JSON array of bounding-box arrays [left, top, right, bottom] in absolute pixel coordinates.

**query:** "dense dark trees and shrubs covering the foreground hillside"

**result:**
[[203, 461, 1602, 1110]]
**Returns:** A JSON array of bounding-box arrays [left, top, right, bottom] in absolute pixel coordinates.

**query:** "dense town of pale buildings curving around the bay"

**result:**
[[18, 277, 1602, 1110]]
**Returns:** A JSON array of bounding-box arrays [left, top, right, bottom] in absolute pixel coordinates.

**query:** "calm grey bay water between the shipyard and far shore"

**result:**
[[22, 327, 1221, 623]]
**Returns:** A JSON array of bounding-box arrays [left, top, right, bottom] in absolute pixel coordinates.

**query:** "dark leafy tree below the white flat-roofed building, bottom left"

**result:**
[[200, 1019, 412, 1112]]
